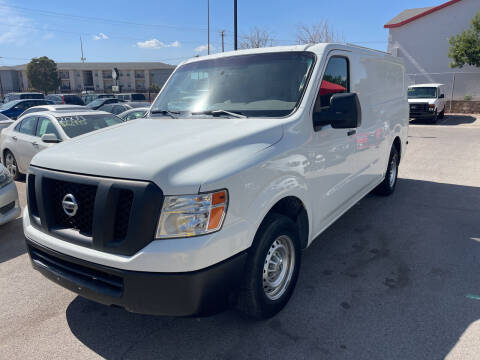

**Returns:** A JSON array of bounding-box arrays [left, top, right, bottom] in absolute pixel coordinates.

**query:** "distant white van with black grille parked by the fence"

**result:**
[[408, 84, 446, 124]]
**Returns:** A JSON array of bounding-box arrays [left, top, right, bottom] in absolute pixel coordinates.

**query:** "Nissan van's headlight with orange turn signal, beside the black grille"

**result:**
[[155, 190, 228, 239]]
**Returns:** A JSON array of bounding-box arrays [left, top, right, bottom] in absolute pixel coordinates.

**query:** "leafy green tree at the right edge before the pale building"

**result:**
[[448, 11, 480, 68]]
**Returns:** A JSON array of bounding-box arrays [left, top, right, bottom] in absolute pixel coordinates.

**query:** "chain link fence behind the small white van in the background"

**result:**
[[408, 72, 480, 101]]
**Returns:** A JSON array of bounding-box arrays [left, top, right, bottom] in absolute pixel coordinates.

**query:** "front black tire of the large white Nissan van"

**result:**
[[237, 214, 301, 319]]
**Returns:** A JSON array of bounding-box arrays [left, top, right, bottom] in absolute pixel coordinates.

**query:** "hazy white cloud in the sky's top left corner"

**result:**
[[0, 0, 32, 45]]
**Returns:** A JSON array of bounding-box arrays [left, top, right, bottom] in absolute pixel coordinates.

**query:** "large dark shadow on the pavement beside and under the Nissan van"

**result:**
[[66, 179, 480, 359]]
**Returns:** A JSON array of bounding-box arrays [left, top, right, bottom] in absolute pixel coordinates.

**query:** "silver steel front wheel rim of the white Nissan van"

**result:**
[[263, 235, 295, 300]]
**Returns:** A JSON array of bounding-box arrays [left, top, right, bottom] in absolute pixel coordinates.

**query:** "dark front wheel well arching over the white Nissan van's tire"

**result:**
[[264, 196, 308, 249]]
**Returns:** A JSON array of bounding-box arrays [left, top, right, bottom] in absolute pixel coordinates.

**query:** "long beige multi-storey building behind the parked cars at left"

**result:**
[[0, 62, 175, 93]]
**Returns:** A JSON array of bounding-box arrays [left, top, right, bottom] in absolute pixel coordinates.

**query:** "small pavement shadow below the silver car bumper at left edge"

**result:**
[[0, 218, 27, 264]]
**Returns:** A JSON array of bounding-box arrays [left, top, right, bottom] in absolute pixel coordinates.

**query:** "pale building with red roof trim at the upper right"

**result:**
[[384, 0, 480, 100]]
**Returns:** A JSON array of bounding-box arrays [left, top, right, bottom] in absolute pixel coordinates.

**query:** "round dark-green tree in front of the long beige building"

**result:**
[[27, 56, 60, 94]]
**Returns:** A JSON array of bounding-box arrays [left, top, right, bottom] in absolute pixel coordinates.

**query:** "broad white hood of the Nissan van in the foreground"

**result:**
[[31, 117, 283, 195]]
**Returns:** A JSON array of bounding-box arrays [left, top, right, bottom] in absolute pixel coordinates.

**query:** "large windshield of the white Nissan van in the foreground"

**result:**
[[151, 52, 315, 117]]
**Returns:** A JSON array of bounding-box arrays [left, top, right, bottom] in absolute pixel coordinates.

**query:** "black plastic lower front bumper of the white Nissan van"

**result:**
[[26, 238, 247, 316]]
